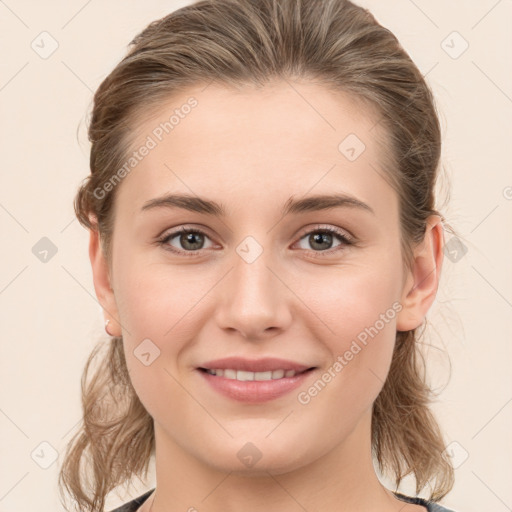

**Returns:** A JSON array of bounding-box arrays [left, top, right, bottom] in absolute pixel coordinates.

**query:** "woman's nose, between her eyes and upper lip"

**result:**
[[215, 247, 292, 341]]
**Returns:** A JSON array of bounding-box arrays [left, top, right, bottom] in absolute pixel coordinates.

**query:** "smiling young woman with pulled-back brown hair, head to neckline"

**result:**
[[60, 0, 460, 512]]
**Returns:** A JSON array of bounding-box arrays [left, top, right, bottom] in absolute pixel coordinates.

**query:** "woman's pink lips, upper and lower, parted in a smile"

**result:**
[[196, 357, 316, 404]]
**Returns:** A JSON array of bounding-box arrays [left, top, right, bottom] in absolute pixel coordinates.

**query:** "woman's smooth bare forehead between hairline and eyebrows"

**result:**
[[118, 81, 391, 218]]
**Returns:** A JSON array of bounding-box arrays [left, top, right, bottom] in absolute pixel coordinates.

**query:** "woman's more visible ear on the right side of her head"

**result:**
[[396, 215, 444, 331]]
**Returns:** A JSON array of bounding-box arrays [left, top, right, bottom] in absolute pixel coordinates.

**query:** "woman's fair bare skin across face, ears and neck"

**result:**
[[89, 82, 443, 512]]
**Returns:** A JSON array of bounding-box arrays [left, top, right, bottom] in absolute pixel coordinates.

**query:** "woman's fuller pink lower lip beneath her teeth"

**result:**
[[197, 370, 314, 404]]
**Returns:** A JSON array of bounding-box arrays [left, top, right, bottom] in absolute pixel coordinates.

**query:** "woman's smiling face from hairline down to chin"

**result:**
[[93, 82, 432, 474]]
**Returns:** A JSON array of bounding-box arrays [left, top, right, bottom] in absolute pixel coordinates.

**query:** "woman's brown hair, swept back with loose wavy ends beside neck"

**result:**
[[59, 0, 454, 512]]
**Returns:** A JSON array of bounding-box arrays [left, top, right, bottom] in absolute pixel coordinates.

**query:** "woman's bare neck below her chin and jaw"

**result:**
[[144, 415, 412, 512]]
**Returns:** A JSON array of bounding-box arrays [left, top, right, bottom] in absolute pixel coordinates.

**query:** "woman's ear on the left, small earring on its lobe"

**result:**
[[89, 229, 121, 336]]
